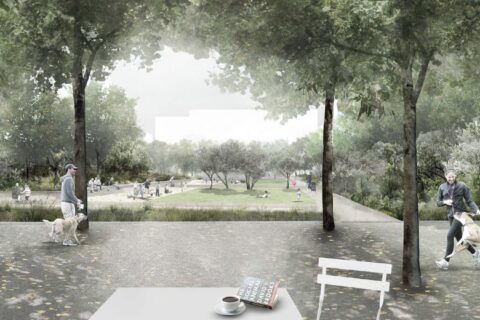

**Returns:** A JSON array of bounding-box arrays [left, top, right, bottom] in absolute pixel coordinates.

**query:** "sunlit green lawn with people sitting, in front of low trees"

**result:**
[[152, 180, 315, 208]]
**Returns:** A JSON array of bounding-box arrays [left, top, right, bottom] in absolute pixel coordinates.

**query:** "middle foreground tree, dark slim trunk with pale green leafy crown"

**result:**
[[175, 0, 386, 230]]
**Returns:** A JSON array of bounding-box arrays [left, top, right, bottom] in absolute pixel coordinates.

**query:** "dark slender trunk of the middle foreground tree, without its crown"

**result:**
[[322, 85, 335, 231]]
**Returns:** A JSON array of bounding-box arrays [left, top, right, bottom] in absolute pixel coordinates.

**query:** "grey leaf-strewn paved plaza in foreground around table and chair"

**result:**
[[0, 221, 480, 320]]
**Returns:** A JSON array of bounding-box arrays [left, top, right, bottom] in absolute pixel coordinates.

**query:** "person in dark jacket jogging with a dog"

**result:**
[[435, 170, 480, 270]]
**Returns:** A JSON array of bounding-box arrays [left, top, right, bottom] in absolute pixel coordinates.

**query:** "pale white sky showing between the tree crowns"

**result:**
[[107, 47, 317, 143]]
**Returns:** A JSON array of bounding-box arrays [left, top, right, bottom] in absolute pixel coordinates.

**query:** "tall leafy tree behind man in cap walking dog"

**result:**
[[4, 0, 186, 220]]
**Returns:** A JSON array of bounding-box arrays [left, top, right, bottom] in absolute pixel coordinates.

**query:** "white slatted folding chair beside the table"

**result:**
[[317, 258, 392, 320]]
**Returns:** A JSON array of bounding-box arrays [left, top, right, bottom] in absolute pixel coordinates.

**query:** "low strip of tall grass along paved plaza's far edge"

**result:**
[[0, 204, 322, 222]]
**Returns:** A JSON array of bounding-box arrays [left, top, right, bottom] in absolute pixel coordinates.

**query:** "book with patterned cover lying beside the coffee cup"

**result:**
[[237, 277, 279, 309]]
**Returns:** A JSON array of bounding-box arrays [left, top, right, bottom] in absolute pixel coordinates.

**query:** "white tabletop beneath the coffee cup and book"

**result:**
[[90, 288, 302, 320]]
